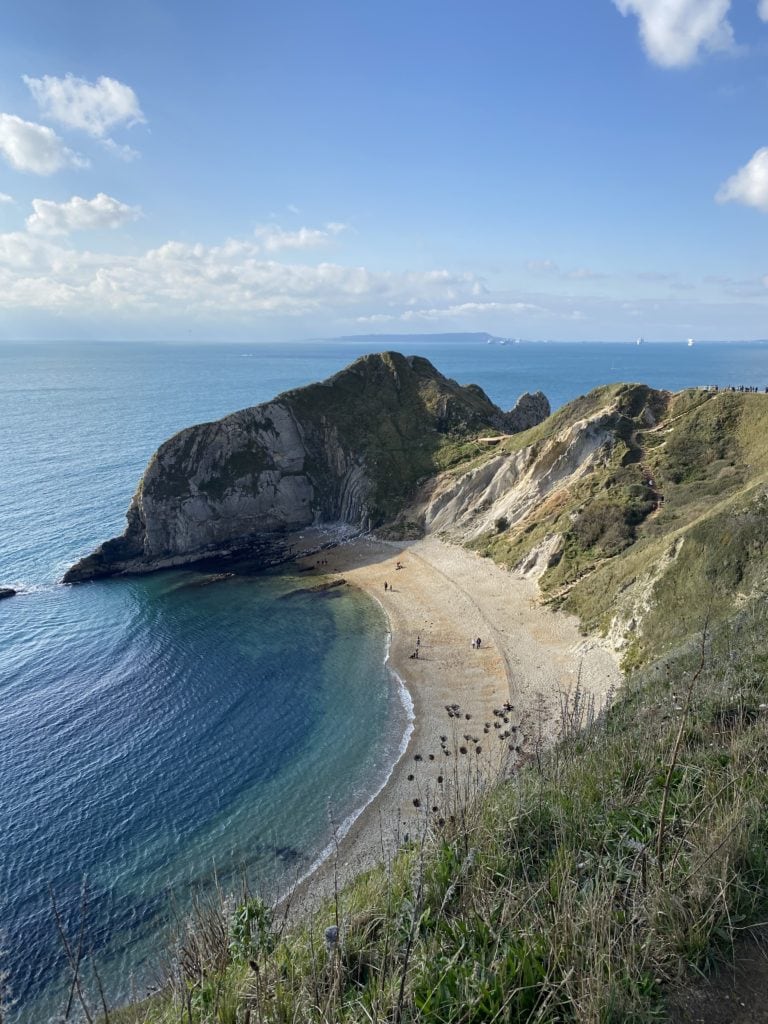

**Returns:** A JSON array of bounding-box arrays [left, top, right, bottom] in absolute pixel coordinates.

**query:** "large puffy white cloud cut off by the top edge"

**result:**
[[613, 0, 737, 68]]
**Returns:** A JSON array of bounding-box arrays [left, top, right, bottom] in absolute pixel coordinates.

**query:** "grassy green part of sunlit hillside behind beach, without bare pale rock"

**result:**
[[473, 385, 768, 662]]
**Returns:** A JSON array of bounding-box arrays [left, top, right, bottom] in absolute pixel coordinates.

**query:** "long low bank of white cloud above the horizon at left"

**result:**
[[0, 226, 487, 318]]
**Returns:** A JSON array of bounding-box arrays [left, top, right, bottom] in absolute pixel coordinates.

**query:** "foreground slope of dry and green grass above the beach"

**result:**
[[97, 609, 768, 1024]]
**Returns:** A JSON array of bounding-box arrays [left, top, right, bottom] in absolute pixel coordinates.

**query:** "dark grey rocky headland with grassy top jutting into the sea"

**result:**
[[65, 352, 549, 583]]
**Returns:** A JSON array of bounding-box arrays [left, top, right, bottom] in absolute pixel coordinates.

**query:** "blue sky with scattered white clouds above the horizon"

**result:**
[[0, 0, 768, 341]]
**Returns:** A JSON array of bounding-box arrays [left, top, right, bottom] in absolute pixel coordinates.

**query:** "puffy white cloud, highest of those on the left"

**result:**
[[24, 75, 145, 138]]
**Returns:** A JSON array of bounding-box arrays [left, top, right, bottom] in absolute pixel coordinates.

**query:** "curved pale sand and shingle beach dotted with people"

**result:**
[[291, 538, 621, 913]]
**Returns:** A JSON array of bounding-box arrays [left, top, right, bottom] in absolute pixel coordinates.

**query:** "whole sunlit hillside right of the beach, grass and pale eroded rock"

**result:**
[[415, 384, 768, 664]]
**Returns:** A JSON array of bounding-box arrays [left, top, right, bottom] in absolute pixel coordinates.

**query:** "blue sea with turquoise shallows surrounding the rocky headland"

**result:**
[[0, 336, 768, 1024]]
